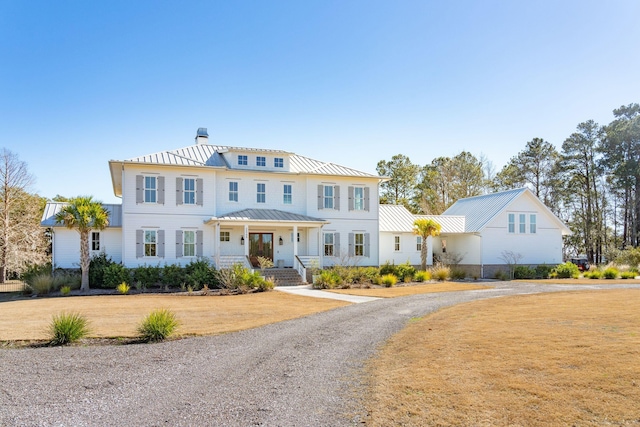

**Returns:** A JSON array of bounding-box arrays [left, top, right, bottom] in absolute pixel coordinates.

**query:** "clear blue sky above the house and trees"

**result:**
[[0, 0, 640, 202]]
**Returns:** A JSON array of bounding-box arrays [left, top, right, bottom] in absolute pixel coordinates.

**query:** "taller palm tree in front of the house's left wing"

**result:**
[[56, 196, 109, 291]]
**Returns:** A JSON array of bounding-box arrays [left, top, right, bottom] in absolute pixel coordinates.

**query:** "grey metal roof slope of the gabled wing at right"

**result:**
[[443, 188, 530, 233]]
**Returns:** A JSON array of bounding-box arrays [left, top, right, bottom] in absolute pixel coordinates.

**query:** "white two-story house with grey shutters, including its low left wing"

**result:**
[[42, 128, 384, 280]]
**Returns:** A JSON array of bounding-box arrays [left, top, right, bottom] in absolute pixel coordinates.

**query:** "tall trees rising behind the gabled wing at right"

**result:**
[[376, 104, 640, 264]]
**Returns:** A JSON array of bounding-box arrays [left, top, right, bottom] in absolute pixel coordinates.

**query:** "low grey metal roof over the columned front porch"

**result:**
[[205, 209, 330, 227]]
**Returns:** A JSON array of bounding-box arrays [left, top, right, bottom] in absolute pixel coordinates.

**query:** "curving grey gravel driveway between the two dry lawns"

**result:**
[[0, 282, 636, 426]]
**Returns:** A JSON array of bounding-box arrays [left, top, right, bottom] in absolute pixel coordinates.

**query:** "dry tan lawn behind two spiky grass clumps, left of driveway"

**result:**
[[0, 292, 349, 341]]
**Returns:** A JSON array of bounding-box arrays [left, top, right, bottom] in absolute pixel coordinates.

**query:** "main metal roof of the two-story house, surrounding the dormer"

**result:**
[[112, 144, 382, 178]]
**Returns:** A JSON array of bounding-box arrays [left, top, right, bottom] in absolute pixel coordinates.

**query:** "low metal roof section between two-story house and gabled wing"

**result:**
[[379, 204, 465, 234]]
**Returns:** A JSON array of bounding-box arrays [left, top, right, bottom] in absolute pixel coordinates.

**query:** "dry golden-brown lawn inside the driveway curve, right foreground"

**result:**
[[367, 289, 640, 426]]
